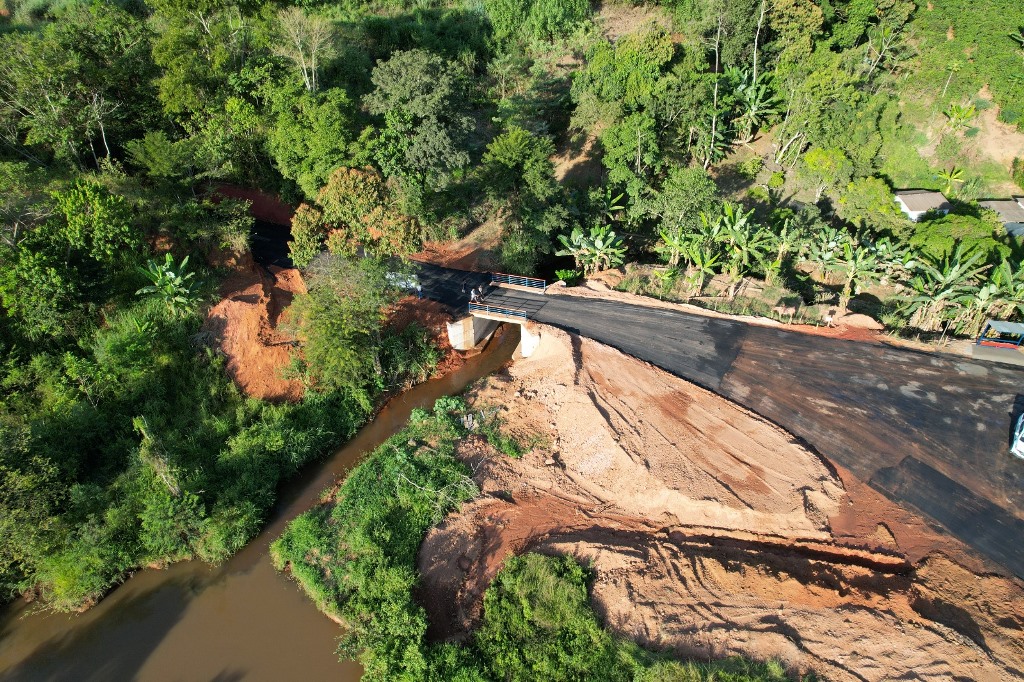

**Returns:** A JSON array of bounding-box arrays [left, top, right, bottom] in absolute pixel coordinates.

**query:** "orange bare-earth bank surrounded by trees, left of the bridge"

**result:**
[[204, 254, 306, 400]]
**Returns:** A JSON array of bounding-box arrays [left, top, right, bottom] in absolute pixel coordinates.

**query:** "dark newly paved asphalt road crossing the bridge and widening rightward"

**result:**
[[421, 266, 1024, 578]]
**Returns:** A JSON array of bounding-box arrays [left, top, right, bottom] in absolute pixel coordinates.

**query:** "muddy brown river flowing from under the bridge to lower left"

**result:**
[[0, 325, 519, 682]]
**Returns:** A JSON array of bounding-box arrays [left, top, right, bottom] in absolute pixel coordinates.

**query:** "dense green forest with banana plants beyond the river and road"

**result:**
[[0, 0, 1024, 630]]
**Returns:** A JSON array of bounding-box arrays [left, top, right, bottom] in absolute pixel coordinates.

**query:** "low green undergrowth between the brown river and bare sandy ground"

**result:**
[[270, 397, 806, 682]]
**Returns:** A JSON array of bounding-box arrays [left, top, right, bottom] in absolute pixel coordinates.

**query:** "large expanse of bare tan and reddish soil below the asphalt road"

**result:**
[[420, 327, 1024, 680]]
